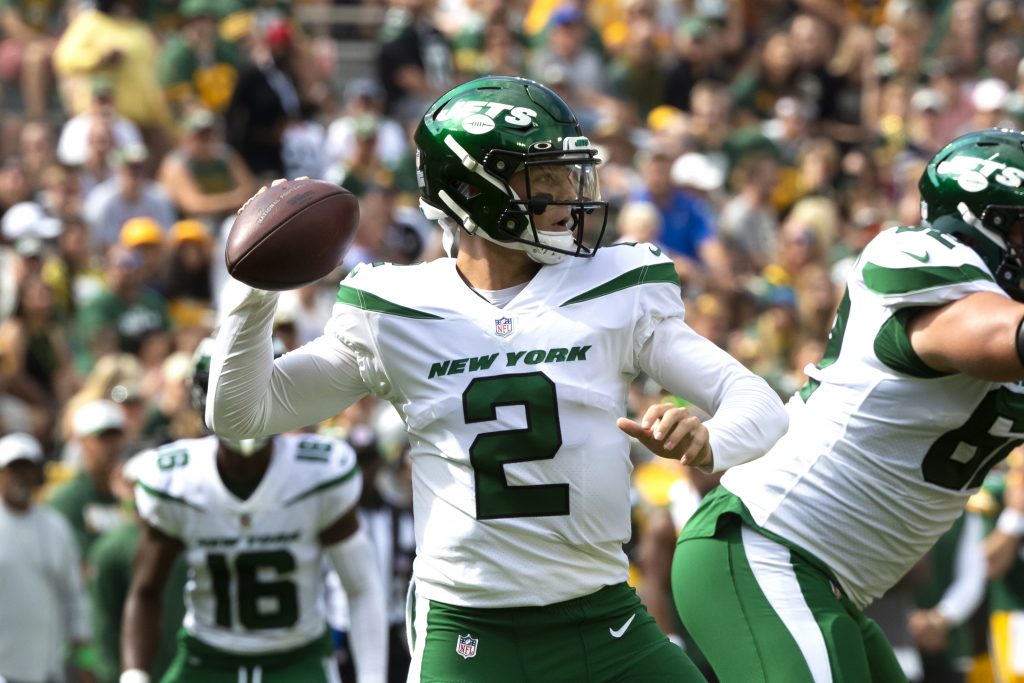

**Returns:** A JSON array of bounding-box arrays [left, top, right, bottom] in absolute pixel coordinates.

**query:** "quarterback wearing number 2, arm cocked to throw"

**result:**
[[207, 77, 785, 683]]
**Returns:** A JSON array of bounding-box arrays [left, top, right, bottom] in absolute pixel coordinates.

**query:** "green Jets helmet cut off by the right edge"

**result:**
[[918, 128, 1024, 301]]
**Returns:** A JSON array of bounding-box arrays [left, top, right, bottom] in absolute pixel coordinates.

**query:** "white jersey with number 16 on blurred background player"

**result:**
[[135, 434, 362, 654]]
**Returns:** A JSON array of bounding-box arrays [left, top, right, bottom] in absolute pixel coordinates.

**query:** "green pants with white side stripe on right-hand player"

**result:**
[[673, 513, 906, 683]]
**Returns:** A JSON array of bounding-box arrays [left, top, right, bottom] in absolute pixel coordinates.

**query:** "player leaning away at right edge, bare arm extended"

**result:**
[[673, 129, 1024, 683]]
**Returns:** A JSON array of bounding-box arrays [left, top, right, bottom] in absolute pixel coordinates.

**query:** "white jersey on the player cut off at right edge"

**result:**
[[722, 227, 1024, 606]]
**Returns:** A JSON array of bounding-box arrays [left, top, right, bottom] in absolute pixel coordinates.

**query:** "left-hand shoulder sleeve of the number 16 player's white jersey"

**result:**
[[134, 446, 195, 539]]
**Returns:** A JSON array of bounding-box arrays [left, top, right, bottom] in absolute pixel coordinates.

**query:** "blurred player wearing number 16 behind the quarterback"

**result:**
[[121, 339, 388, 683]]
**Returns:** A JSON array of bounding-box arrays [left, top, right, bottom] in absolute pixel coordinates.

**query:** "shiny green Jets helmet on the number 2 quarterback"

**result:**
[[414, 76, 607, 263]]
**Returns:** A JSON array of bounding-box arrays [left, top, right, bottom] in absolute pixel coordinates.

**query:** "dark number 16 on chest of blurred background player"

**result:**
[[206, 550, 299, 631]]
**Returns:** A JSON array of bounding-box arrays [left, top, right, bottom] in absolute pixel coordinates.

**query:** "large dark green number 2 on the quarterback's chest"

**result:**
[[462, 373, 569, 519]]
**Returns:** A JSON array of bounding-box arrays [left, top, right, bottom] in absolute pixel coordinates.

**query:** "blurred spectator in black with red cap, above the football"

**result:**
[[225, 20, 303, 179]]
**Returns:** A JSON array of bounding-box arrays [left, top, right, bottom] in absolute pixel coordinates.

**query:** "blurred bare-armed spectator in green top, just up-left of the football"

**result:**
[[157, 110, 256, 221]]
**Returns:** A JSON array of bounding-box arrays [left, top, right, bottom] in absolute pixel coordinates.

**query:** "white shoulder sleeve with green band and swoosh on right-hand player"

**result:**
[[854, 227, 1006, 309]]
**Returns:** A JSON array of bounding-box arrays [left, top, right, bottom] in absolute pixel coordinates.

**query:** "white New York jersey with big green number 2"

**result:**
[[328, 245, 686, 607]]
